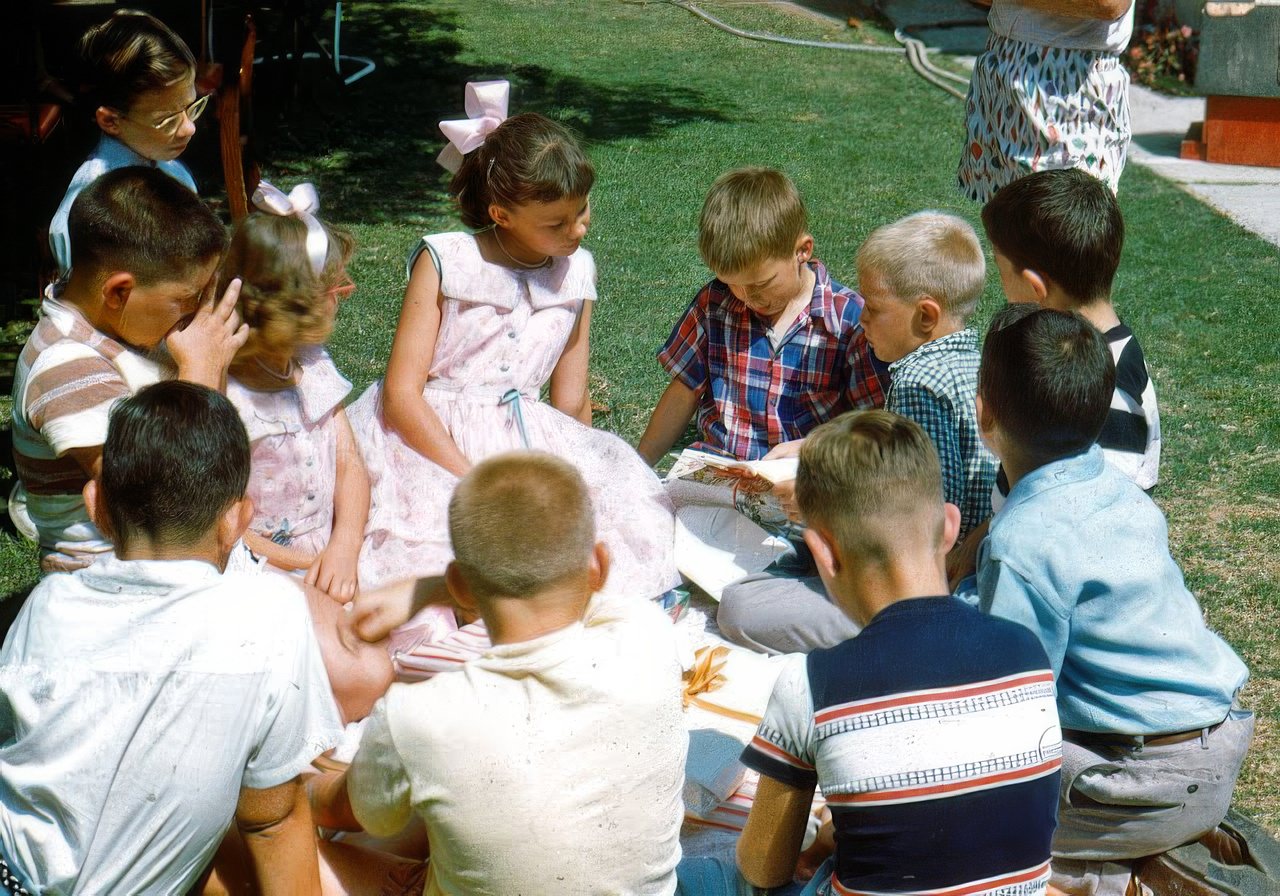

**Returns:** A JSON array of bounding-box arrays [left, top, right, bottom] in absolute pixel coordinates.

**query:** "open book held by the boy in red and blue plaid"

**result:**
[[667, 448, 799, 600]]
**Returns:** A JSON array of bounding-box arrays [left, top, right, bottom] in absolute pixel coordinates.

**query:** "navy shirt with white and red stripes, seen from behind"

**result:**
[[742, 598, 1061, 896]]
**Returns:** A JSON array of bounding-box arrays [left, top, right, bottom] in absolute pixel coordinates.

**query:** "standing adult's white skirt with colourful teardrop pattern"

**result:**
[[957, 35, 1130, 202]]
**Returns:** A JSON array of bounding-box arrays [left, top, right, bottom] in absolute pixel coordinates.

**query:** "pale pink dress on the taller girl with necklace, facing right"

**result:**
[[347, 233, 680, 606]]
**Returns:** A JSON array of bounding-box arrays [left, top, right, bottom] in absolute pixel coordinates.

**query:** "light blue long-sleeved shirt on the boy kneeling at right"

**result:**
[[977, 445, 1249, 735]]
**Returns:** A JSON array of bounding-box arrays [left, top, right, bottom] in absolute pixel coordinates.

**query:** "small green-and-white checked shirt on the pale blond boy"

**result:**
[[884, 329, 996, 538]]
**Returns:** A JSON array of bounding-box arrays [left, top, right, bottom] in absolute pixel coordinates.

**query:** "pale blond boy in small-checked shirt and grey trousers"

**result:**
[[717, 211, 996, 653]]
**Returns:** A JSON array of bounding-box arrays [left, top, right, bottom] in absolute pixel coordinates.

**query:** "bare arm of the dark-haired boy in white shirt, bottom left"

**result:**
[[236, 778, 320, 896]]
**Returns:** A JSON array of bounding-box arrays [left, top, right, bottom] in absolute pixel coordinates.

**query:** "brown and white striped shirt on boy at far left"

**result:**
[[13, 298, 161, 566]]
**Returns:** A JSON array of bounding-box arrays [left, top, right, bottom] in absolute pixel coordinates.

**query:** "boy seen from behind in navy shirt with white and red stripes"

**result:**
[[737, 411, 1060, 895]]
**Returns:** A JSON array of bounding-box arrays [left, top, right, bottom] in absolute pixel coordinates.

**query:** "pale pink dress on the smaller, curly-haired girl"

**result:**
[[227, 347, 351, 554]]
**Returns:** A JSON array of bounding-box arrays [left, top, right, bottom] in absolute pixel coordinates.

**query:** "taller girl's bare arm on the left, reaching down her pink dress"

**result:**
[[383, 251, 471, 476]]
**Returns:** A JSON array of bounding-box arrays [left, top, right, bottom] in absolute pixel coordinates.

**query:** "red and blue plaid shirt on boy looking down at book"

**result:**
[[658, 260, 888, 461]]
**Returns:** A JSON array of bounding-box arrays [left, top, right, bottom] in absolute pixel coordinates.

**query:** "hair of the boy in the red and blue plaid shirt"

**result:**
[[698, 168, 809, 274]]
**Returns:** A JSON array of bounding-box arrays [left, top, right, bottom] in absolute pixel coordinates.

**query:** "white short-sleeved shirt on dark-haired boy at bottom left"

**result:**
[[0, 558, 342, 893]]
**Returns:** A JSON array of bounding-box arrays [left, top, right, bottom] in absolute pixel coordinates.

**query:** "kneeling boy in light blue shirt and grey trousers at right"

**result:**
[[977, 305, 1253, 893]]
